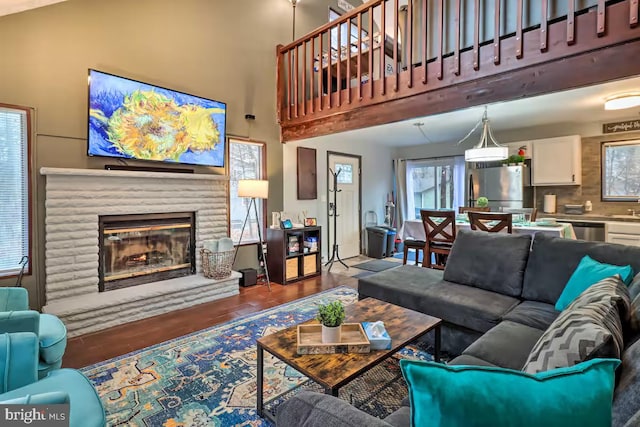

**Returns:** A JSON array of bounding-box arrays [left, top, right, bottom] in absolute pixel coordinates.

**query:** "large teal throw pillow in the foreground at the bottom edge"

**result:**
[[400, 359, 620, 427]]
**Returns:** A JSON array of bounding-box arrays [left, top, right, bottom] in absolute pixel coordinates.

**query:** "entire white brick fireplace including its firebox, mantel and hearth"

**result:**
[[40, 168, 240, 336]]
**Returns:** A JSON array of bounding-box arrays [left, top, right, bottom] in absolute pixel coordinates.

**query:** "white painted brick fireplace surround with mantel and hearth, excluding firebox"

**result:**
[[40, 168, 240, 336]]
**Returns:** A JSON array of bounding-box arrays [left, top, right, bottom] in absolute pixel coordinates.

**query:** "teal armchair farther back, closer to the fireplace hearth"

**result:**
[[0, 288, 67, 378]]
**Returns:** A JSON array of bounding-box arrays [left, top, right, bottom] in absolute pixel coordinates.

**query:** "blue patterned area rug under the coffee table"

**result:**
[[82, 287, 431, 427]]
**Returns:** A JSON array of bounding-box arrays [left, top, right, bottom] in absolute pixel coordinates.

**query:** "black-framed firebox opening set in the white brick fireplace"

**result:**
[[99, 212, 196, 292]]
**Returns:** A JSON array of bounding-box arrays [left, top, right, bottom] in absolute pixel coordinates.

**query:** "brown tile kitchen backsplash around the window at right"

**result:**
[[533, 132, 640, 215]]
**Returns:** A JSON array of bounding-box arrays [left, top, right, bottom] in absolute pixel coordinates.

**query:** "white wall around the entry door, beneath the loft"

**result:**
[[282, 138, 393, 260]]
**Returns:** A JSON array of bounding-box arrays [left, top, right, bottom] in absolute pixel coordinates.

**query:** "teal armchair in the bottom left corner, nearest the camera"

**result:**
[[0, 332, 106, 427]]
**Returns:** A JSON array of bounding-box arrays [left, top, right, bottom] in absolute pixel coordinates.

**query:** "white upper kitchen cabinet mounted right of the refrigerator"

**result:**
[[531, 135, 582, 186]]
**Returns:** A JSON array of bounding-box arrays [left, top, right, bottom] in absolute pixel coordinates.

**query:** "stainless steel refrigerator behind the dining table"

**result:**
[[466, 165, 533, 211]]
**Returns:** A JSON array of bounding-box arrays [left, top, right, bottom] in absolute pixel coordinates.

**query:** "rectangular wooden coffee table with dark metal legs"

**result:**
[[256, 298, 442, 422]]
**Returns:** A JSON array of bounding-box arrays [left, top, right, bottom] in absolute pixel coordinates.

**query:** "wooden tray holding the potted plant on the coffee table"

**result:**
[[297, 323, 371, 354]]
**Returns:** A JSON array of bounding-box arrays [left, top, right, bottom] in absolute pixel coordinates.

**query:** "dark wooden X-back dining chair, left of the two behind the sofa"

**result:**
[[420, 209, 456, 270]]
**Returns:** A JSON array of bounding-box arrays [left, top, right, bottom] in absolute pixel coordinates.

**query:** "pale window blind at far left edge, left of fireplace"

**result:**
[[0, 107, 29, 276]]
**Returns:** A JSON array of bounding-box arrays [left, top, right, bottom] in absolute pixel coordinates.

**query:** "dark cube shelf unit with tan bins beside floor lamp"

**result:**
[[267, 227, 322, 285]]
